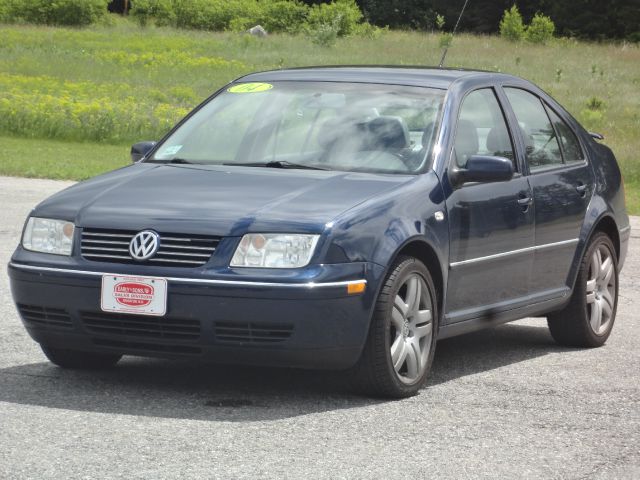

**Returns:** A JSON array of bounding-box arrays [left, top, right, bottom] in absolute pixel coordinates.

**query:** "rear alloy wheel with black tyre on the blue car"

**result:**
[[548, 232, 618, 347]]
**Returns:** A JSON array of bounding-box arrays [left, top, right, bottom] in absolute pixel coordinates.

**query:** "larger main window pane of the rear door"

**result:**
[[505, 88, 562, 172]]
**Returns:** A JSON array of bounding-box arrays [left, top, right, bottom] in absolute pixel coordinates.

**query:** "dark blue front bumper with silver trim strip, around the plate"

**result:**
[[9, 259, 383, 369]]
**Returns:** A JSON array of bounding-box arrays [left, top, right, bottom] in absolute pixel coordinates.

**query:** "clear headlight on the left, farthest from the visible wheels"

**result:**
[[22, 217, 75, 255]]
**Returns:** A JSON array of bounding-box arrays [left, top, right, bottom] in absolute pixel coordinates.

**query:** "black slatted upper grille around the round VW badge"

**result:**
[[81, 228, 220, 267]]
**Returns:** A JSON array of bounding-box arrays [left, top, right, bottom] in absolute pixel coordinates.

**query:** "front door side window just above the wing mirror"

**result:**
[[453, 88, 516, 170]]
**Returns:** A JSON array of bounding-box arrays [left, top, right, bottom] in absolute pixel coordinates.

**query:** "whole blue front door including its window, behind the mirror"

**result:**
[[445, 88, 534, 322]]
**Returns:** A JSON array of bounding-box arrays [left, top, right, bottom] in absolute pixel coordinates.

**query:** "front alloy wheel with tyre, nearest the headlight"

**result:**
[[355, 257, 438, 398]]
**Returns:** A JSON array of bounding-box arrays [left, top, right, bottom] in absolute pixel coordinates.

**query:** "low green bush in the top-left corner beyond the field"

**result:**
[[0, 0, 109, 27]]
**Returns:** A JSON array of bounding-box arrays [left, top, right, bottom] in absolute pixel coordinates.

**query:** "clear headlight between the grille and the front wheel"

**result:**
[[231, 233, 319, 268]]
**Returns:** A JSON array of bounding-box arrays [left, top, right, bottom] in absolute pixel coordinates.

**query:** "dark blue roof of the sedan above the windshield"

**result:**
[[238, 66, 515, 89]]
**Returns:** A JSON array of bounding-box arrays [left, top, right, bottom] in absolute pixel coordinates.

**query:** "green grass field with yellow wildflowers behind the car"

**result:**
[[0, 20, 640, 213]]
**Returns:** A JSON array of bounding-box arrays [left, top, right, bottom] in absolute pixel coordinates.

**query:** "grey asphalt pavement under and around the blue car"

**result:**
[[0, 177, 640, 480]]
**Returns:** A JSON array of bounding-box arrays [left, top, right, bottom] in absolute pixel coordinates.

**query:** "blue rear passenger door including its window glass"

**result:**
[[504, 88, 594, 294]]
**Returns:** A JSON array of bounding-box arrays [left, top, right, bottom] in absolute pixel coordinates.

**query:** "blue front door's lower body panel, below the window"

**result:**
[[446, 177, 534, 320]]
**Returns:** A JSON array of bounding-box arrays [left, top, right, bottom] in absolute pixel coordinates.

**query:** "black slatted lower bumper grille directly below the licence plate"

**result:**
[[80, 312, 200, 340]]
